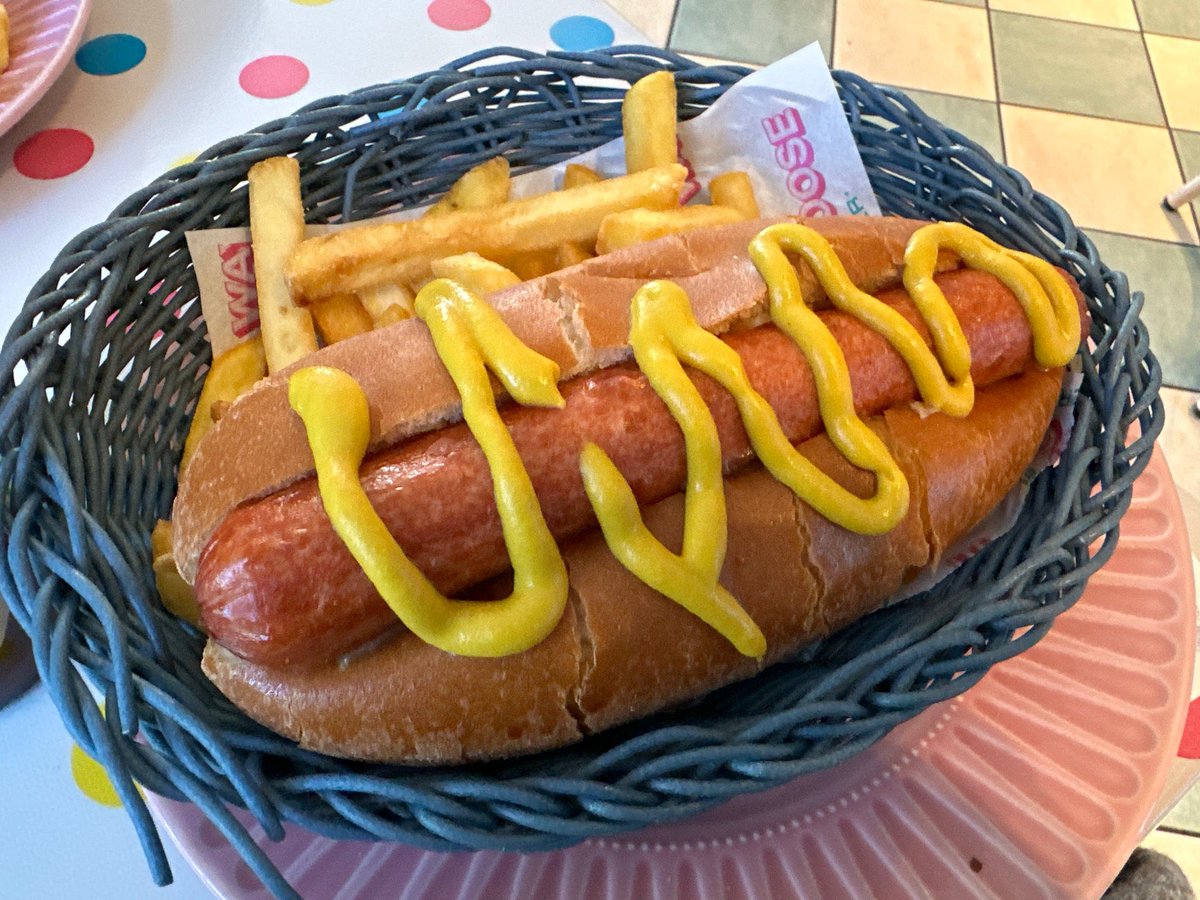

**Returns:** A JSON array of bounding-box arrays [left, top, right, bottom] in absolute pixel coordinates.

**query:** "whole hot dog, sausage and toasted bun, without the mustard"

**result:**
[[175, 214, 1079, 762]]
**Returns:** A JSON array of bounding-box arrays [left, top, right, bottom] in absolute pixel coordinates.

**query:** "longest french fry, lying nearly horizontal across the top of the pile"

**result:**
[[287, 163, 688, 304]]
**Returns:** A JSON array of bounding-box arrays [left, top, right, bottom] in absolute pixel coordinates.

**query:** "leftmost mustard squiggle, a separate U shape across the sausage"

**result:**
[[288, 278, 568, 656]]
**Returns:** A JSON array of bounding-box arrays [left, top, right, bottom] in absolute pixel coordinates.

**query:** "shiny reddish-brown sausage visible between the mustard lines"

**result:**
[[196, 270, 1069, 666]]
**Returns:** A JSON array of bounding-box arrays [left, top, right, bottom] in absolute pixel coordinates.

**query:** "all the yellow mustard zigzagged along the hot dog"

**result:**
[[288, 223, 1079, 656]]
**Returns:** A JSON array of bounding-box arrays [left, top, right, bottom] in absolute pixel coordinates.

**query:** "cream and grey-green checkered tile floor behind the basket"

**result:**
[[610, 0, 1200, 893]]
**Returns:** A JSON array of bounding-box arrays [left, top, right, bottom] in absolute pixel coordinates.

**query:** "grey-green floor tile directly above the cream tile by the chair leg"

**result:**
[[991, 12, 1163, 125]]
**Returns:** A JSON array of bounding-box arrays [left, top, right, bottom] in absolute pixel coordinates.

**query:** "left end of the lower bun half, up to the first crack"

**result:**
[[203, 595, 590, 763]]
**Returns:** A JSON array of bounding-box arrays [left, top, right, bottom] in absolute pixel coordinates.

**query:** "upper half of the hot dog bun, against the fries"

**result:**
[[172, 217, 958, 583]]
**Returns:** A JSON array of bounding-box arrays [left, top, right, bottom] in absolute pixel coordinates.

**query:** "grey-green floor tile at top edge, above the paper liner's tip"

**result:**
[[668, 0, 834, 65]]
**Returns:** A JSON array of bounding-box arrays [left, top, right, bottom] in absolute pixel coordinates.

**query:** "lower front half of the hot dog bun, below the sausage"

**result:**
[[204, 370, 1061, 763]]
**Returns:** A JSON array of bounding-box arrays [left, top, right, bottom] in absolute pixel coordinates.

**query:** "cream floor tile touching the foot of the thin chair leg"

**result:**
[[1000, 103, 1196, 244]]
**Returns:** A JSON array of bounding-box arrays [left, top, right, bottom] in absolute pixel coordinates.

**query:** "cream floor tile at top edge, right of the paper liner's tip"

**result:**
[[833, 0, 996, 100]]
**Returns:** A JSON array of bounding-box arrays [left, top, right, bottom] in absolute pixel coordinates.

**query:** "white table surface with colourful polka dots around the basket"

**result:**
[[0, 0, 1200, 900]]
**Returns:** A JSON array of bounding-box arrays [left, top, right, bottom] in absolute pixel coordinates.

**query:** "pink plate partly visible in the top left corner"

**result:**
[[0, 0, 91, 134]]
